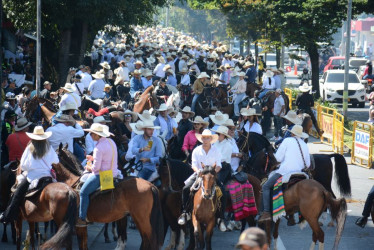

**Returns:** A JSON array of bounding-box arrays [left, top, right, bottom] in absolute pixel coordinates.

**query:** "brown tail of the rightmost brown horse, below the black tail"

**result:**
[[324, 190, 347, 250]]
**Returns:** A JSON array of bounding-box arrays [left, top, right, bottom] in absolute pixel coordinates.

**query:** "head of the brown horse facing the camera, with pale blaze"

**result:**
[[199, 163, 217, 200]]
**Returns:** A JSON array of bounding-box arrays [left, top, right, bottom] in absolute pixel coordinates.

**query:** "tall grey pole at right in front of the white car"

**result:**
[[343, 0, 352, 118]]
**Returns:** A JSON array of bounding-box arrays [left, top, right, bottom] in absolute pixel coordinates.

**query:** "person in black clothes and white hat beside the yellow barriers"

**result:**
[[295, 83, 322, 135]]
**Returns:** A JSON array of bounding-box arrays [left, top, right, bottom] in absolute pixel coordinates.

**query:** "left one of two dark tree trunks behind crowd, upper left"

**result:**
[[58, 29, 71, 86]]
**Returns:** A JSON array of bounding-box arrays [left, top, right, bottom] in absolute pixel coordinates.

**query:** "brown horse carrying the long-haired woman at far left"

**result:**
[[12, 163, 78, 249]]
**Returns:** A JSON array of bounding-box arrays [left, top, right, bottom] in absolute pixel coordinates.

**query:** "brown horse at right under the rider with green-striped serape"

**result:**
[[247, 151, 347, 250]]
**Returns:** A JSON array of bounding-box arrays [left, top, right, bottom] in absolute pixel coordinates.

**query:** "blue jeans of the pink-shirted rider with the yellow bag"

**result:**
[[79, 174, 100, 220]]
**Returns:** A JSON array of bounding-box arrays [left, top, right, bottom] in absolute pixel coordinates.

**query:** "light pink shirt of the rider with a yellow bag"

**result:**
[[92, 137, 118, 177]]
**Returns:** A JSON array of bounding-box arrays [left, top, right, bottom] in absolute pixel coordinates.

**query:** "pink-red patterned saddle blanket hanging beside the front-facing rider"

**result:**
[[227, 180, 257, 221]]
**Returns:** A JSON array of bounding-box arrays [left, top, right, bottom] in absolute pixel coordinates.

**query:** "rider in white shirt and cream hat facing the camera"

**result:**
[[178, 129, 221, 225]]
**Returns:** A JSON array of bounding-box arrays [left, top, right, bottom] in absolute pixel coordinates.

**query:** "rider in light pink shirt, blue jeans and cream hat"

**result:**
[[77, 123, 119, 226]]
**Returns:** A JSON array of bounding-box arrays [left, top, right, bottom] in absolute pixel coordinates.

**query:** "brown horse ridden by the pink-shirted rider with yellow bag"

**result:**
[[53, 145, 164, 249]]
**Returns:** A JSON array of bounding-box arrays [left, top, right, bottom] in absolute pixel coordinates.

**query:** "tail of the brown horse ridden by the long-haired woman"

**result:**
[[41, 190, 78, 249]]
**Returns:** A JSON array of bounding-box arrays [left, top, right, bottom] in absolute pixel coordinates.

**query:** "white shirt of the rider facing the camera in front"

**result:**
[[191, 145, 221, 170]]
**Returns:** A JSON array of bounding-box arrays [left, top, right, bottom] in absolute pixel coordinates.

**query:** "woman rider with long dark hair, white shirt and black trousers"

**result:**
[[0, 126, 59, 223]]
